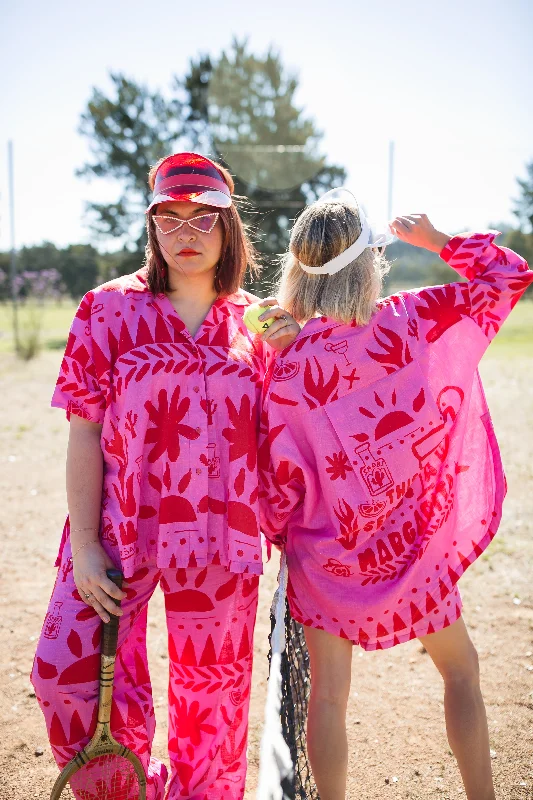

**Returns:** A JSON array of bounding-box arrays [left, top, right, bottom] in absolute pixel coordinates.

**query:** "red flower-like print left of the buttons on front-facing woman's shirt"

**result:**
[[144, 386, 200, 464]]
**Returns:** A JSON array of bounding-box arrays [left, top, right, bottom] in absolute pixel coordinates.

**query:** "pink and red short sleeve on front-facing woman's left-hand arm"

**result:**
[[51, 292, 109, 424]]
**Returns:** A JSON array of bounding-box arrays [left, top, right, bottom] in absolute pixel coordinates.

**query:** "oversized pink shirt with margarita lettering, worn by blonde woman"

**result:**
[[259, 232, 533, 646]]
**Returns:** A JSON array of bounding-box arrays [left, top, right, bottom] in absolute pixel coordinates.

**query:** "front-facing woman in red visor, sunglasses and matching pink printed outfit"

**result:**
[[32, 153, 298, 800]]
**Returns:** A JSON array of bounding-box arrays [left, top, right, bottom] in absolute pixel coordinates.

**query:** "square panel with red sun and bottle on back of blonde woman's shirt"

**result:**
[[325, 362, 446, 502]]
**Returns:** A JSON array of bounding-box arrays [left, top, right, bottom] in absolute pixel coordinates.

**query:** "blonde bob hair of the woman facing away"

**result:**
[[277, 201, 390, 325]]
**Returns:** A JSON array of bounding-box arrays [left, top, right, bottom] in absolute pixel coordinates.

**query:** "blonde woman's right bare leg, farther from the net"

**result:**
[[420, 618, 495, 800]]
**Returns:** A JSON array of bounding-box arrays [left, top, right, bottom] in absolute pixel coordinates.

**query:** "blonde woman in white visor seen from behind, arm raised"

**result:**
[[259, 195, 533, 800]]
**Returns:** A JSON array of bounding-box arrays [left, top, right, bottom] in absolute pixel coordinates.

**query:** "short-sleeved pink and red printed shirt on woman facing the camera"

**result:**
[[52, 270, 266, 577]]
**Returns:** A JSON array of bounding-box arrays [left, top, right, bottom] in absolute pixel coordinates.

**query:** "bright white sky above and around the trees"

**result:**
[[0, 0, 533, 250]]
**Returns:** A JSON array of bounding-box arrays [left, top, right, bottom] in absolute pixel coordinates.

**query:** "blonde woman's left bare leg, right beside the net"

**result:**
[[305, 627, 353, 800]]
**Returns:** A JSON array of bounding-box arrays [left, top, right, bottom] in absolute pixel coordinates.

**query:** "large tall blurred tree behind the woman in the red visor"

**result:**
[[80, 41, 345, 291]]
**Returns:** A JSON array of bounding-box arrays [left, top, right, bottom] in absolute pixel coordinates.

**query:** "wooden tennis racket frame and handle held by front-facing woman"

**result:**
[[50, 569, 146, 800]]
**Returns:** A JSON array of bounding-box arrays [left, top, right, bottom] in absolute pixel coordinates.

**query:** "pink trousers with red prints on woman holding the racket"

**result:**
[[31, 552, 259, 800]]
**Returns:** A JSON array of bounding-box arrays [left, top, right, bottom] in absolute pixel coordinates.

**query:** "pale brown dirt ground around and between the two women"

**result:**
[[0, 352, 533, 800]]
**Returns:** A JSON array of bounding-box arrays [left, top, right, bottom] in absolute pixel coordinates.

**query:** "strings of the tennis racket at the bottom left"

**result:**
[[61, 755, 140, 800]]
